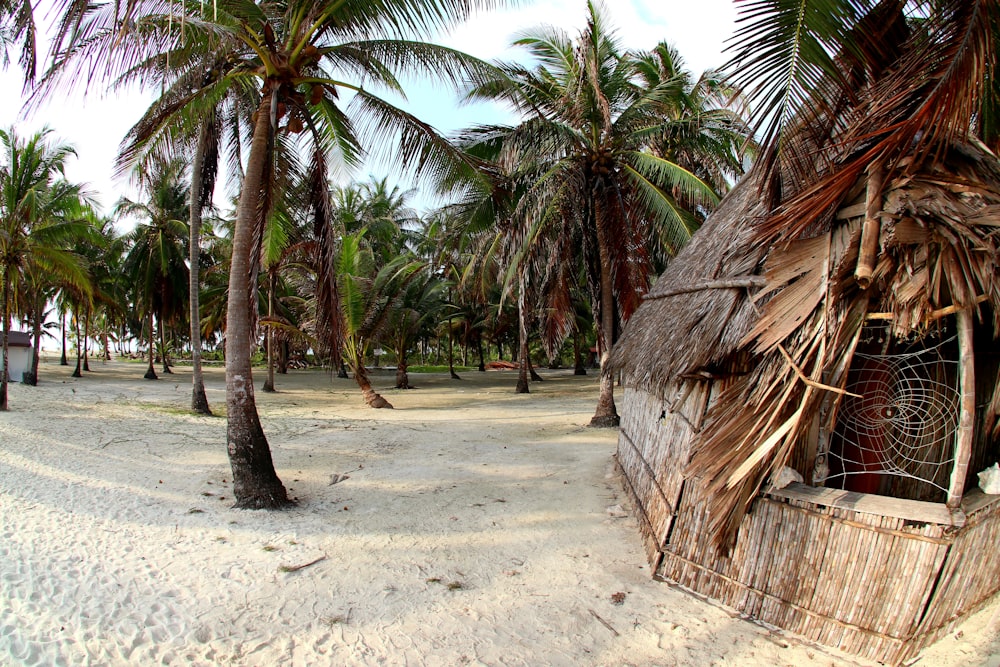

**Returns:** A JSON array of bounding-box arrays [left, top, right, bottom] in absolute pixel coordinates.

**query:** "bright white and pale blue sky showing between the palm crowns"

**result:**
[[0, 0, 736, 223]]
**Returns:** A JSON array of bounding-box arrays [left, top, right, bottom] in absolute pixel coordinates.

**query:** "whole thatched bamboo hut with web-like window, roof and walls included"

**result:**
[[611, 3, 1000, 664]]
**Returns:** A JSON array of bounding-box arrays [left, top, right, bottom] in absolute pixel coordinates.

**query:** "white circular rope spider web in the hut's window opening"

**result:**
[[830, 337, 959, 491]]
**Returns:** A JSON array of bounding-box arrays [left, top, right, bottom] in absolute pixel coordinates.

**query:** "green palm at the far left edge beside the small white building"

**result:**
[[0, 124, 90, 410]]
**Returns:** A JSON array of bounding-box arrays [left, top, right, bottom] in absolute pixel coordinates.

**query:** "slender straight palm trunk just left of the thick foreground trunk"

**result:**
[[188, 121, 212, 415]]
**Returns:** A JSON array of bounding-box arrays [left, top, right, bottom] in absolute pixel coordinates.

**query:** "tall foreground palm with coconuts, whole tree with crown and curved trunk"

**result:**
[[48, 0, 508, 508]]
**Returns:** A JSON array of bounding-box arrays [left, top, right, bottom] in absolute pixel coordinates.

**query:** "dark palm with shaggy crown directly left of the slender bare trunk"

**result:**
[[115, 159, 189, 380]]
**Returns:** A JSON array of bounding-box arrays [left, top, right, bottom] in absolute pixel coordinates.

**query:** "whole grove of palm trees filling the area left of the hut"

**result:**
[[0, 0, 748, 508]]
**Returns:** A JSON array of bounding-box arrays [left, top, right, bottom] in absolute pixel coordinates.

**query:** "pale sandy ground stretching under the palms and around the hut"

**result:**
[[0, 362, 1000, 666]]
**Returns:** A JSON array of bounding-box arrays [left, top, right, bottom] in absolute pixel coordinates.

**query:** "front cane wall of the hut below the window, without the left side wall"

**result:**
[[657, 483, 1000, 664]]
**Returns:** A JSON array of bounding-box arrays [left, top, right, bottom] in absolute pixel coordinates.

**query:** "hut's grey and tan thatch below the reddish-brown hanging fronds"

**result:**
[[612, 137, 1000, 539]]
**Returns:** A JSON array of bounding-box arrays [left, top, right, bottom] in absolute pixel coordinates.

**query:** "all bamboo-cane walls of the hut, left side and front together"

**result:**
[[617, 368, 1000, 664]]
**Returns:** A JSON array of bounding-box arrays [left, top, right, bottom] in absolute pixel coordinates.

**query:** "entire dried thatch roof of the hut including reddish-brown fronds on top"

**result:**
[[612, 3, 1000, 547]]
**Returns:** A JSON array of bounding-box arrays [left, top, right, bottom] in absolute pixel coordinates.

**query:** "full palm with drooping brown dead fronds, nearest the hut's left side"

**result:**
[[465, 2, 752, 426]]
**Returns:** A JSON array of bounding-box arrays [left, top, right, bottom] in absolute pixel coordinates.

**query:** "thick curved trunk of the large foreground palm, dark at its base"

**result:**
[[226, 91, 291, 509]]
